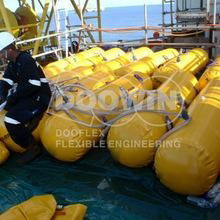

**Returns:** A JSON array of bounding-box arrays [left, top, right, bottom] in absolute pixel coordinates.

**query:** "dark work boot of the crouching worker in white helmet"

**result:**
[[17, 141, 41, 164]]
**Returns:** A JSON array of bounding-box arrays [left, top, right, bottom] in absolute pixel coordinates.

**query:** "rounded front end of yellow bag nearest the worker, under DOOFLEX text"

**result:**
[[41, 111, 101, 162]]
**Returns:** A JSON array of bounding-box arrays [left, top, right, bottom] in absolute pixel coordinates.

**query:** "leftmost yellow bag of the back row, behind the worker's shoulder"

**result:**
[[44, 47, 104, 78]]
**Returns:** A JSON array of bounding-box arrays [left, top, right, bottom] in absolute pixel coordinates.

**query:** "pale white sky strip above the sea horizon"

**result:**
[[4, 0, 162, 11]]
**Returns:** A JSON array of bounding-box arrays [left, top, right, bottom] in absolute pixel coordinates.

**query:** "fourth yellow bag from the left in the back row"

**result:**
[[115, 49, 178, 76]]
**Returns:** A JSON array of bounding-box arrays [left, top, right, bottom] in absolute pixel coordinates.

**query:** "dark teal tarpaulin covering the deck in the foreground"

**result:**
[[0, 148, 220, 220]]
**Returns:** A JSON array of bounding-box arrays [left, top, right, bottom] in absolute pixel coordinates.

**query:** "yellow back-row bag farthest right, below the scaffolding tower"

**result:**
[[153, 48, 209, 88]]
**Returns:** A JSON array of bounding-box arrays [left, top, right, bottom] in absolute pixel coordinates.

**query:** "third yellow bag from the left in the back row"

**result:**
[[94, 47, 153, 73]]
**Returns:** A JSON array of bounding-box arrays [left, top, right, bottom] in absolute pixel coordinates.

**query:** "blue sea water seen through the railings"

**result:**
[[52, 5, 169, 42]]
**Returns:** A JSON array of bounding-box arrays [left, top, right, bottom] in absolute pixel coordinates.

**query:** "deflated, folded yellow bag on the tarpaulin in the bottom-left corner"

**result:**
[[0, 195, 87, 220]]
